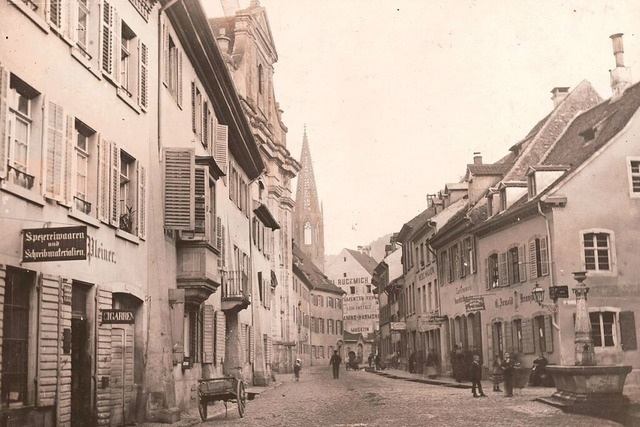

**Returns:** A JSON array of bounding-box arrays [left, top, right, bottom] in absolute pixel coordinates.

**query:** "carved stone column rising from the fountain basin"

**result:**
[[573, 271, 596, 366]]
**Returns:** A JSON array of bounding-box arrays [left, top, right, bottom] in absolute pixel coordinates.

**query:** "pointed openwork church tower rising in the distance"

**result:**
[[293, 126, 324, 271]]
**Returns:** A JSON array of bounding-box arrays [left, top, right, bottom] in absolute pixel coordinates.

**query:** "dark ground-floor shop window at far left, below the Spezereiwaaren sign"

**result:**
[[0, 268, 36, 406]]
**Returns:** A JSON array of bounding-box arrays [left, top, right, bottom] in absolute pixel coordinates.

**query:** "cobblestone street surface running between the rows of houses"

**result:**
[[196, 366, 632, 427]]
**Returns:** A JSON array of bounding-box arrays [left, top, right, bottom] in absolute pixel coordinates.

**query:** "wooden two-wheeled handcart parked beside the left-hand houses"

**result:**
[[198, 377, 247, 421]]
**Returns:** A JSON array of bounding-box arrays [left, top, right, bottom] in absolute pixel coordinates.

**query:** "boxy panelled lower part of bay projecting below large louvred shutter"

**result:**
[[176, 239, 222, 305]]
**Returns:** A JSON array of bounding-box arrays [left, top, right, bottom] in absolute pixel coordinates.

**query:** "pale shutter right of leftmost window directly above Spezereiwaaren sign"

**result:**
[[44, 101, 66, 201]]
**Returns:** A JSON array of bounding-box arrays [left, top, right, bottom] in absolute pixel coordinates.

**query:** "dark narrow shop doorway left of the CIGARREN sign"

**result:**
[[71, 282, 92, 427]]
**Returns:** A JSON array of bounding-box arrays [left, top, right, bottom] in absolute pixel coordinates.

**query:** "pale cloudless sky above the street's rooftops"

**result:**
[[201, 0, 640, 255]]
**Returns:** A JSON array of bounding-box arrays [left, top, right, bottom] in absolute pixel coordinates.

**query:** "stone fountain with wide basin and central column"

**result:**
[[540, 271, 632, 418]]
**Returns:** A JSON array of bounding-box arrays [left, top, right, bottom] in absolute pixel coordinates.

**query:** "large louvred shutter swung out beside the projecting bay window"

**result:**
[[164, 148, 195, 230]]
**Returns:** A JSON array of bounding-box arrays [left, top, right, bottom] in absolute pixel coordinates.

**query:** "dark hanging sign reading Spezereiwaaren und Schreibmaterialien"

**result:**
[[22, 225, 87, 262]]
